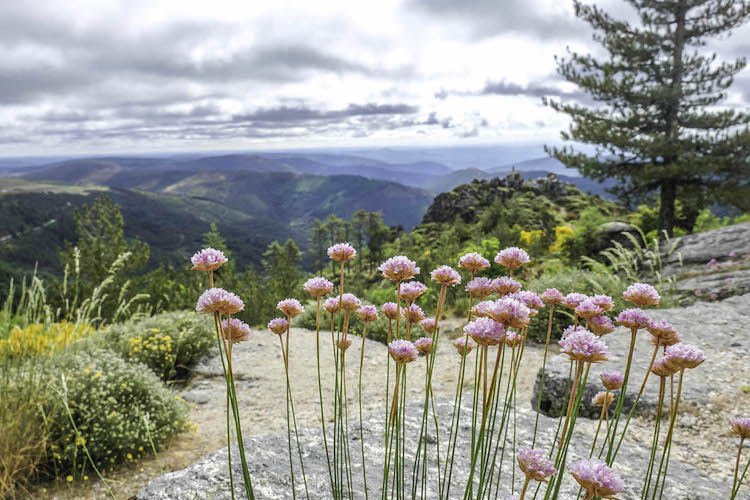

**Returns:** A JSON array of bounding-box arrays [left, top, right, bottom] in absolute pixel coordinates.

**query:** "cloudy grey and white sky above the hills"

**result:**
[[0, 0, 750, 156]]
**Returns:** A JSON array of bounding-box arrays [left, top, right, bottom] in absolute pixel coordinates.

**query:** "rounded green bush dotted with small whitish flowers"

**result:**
[[44, 345, 189, 476]]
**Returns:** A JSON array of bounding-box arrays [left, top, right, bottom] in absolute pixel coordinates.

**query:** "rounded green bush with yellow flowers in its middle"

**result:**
[[97, 311, 216, 380]]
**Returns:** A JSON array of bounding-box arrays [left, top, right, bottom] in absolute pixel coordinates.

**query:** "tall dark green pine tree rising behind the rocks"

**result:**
[[545, 0, 750, 235]]
